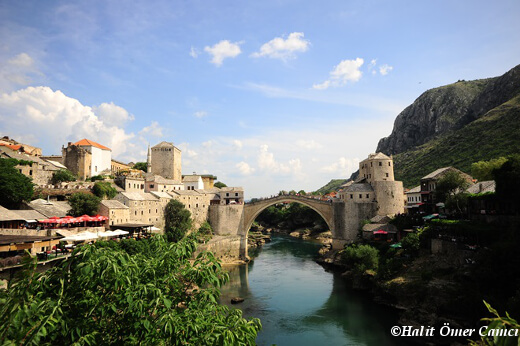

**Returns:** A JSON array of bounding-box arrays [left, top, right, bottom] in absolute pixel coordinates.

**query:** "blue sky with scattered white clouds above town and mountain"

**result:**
[[0, 0, 520, 197]]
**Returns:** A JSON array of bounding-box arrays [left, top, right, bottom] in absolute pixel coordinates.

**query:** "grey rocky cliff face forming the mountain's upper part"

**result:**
[[377, 65, 520, 155]]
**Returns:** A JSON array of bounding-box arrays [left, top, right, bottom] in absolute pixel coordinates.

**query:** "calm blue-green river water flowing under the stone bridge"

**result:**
[[221, 235, 399, 346]]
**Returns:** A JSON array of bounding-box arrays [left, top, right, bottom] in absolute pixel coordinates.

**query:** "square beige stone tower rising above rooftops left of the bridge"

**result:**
[[150, 142, 182, 181]]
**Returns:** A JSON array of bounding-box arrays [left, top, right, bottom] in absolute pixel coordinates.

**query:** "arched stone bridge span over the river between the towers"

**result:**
[[243, 195, 335, 236]]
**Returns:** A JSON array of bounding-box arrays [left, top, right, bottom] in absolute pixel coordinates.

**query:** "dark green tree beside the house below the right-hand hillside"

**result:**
[[434, 171, 470, 212]]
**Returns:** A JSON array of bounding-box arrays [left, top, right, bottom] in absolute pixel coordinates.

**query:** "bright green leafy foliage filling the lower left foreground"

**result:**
[[0, 235, 261, 345]]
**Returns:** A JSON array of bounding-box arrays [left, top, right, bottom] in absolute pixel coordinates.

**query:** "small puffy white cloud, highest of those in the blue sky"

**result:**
[[251, 32, 310, 60]]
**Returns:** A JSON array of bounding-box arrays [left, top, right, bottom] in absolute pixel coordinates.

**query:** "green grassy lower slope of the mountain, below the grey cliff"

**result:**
[[394, 95, 520, 188]]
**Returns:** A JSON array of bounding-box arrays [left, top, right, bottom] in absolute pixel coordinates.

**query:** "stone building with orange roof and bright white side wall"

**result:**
[[61, 139, 112, 180]]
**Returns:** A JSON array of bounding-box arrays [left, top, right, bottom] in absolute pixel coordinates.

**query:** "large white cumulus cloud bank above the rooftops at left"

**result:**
[[0, 86, 139, 157]]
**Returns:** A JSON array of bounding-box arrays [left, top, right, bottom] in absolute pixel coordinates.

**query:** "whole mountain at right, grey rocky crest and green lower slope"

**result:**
[[377, 65, 520, 187]]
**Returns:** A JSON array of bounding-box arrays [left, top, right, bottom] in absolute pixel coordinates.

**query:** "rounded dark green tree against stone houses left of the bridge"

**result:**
[[164, 199, 192, 242]]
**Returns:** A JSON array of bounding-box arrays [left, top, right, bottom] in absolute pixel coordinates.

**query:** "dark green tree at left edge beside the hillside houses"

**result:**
[[0, 159, 34, 207]]
